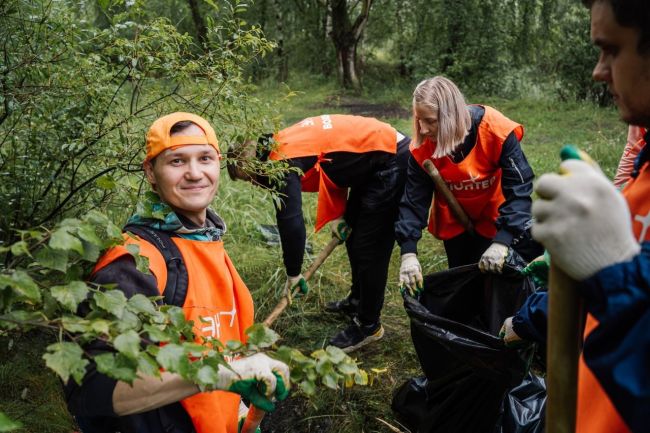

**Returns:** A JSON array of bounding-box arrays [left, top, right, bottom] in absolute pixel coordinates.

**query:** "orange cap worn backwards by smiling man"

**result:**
[[144, 112, 219, 161]]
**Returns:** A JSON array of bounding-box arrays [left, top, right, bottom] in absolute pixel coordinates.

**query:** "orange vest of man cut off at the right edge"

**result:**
[[576, 154, 650, 433]]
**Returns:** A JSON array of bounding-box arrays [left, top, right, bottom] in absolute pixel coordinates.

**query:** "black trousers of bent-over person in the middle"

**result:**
[[345, 137, 408, 324]]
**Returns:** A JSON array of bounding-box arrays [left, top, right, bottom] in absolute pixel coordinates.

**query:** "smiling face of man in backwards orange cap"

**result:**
[[144, 125, 220, 225]]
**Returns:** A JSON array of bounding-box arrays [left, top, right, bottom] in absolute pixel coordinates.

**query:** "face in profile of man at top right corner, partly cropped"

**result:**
[[591, 0, 650, 127]]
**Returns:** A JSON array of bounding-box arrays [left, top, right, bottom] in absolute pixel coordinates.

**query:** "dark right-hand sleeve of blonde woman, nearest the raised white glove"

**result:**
[[493, 132, 535, 246]]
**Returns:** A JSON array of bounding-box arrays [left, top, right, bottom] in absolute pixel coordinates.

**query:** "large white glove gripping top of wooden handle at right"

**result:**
[[532, 159, 640, 281]]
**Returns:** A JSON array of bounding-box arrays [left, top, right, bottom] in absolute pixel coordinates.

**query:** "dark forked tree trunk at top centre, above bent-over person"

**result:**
[[330, 0, 373, 90]]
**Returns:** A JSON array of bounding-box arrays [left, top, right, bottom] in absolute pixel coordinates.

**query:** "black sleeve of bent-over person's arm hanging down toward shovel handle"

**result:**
[[275, 171, 307, 277]]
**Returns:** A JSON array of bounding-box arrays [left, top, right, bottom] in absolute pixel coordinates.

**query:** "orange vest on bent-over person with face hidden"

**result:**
[[269, 114, 397, 231]]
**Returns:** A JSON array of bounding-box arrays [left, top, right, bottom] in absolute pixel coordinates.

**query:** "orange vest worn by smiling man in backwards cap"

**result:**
[[93, 235, 254, 433]]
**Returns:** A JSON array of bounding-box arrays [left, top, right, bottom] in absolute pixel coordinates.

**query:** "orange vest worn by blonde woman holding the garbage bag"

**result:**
[[410, 105, 524, 240]]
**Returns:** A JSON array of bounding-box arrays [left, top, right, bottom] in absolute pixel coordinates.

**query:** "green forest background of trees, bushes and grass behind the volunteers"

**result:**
[[0, 0, 626, 433]]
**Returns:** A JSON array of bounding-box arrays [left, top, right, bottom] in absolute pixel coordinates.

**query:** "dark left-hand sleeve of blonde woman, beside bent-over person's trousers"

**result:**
[[395, 155, 434, 254]]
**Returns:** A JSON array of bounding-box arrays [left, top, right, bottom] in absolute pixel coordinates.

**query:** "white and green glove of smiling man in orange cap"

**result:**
[[216, 353, 290, 412]]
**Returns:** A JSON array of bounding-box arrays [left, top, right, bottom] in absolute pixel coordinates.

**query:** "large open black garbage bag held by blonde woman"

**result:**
[[392, 256, 535, 433]]
